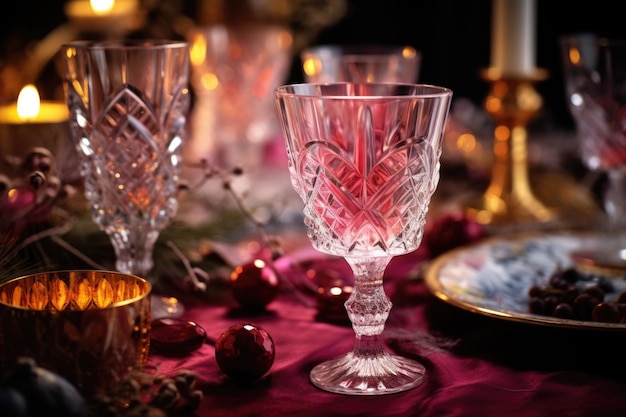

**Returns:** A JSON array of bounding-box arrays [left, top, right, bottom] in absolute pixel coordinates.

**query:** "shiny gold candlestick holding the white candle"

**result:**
[[468, 68, 554, 224]]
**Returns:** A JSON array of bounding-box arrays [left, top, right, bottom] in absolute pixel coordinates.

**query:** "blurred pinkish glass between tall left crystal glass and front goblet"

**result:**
[[185, 23, 292, 172]]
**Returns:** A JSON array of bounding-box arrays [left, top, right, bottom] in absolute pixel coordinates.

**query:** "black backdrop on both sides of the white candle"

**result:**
[[310, 0, 626, 129]]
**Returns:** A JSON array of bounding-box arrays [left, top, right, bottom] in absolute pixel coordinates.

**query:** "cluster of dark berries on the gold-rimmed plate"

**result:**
[[528, 267, 626, 323]]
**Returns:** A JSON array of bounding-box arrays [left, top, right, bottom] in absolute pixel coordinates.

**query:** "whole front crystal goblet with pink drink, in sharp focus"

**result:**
[[276, 83, 452, 395]]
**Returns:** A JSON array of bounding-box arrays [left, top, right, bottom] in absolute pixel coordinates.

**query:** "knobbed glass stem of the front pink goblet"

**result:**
[[345, 256, 392, 350]]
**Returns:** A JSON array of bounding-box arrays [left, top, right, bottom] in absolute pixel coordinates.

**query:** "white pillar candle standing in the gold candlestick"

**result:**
[[491, 0, 536, 76]]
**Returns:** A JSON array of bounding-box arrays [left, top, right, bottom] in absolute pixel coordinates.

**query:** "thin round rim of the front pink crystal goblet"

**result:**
[[274, 82, 453, 100]]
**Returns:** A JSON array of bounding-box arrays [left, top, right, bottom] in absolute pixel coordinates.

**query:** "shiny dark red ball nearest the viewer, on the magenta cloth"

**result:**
[[215, 323, 275, 381]]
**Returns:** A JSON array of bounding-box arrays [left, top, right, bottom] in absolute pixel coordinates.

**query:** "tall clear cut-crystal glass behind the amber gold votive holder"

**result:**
[[61, 40, 190, 276]]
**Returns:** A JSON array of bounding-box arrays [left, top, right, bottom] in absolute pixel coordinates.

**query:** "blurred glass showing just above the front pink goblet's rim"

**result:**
[[300, 44, 421, 83]]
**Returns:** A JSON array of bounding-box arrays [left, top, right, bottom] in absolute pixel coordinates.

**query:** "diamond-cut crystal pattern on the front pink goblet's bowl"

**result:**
[[297, 106, 438, 256]]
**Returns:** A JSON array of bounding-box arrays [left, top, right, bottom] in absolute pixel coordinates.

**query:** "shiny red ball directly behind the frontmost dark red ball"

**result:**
[[230, 259, 279, 310]]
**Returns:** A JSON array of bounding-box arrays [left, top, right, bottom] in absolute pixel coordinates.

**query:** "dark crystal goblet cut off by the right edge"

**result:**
[[560, 34, 626, 268]]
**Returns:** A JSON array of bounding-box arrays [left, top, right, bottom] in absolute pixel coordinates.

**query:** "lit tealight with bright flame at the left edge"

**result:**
[[0, 85, 69, 157]]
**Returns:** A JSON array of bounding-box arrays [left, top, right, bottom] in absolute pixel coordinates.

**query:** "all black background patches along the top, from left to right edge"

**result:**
[[0, 0, 626, 128]]
